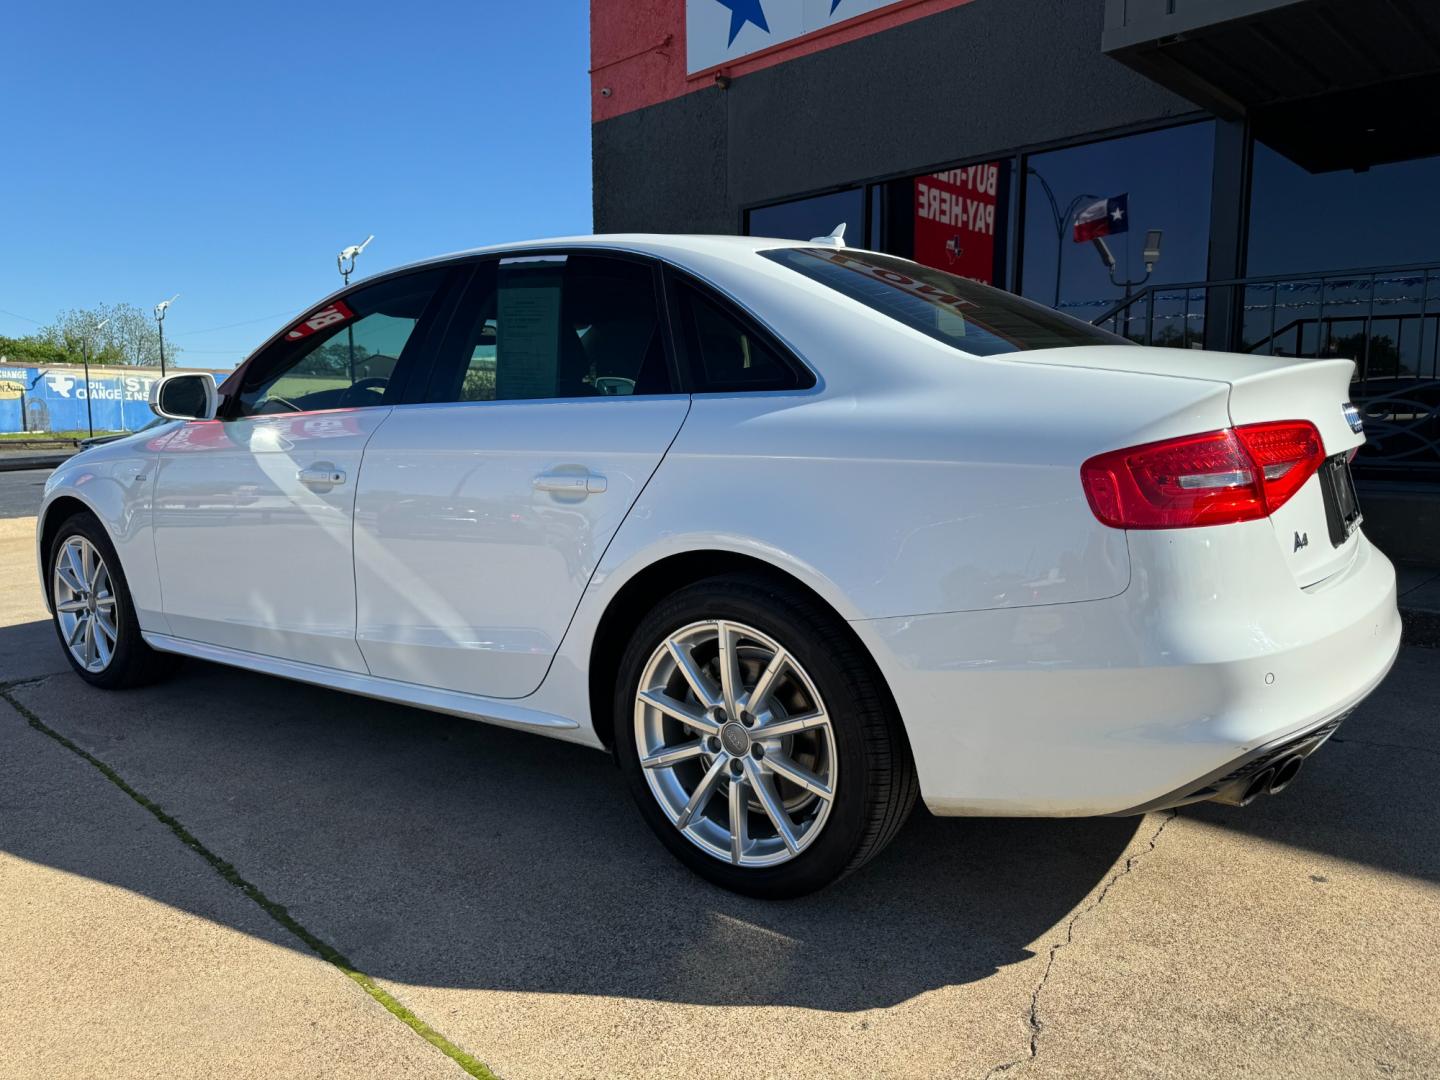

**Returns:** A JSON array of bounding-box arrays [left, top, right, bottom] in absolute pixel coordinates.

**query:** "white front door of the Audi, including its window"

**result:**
[[154, 269, 449, 672]]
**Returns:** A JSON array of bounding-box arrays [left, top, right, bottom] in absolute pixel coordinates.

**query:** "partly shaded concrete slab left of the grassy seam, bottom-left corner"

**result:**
[[0, 707, 464, 1080]]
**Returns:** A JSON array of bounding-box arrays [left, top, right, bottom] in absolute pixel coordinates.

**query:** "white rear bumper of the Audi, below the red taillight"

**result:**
[[852, 521, 1400, 816]]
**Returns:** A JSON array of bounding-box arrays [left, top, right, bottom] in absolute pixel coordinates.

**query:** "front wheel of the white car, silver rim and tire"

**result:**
[[48, 513, 174, 690]]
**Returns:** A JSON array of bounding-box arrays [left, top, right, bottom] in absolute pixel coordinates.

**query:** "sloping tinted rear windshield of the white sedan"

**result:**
[[760, 248, 1132, 356]]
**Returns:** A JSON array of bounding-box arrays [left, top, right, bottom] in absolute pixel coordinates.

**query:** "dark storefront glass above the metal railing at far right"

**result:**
[[1247, 143, 1440, 276]]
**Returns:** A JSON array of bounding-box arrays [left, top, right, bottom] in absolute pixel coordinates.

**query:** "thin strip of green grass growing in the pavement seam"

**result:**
[[0, 680, 498, 1080]]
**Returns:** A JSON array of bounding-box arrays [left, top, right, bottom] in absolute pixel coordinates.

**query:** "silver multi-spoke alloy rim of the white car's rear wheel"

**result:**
[[635, 619, 838, 867]]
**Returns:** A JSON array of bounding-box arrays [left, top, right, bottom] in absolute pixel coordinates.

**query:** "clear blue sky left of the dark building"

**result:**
[[0, 0, 590, 367]]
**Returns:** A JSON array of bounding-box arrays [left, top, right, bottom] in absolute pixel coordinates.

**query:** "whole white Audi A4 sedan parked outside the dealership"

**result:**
[[37, 236, 1400, 897]]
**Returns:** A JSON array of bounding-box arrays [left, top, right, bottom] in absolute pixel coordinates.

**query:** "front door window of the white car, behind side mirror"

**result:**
[[236, 269, 448, 416]]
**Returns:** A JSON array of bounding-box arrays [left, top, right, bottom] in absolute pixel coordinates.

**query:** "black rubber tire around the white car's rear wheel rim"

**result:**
[[613, 575, 919, 900]]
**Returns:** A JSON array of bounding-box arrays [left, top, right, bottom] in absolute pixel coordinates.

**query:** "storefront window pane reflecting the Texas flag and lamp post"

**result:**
[[1021, 121, 1215, 344]]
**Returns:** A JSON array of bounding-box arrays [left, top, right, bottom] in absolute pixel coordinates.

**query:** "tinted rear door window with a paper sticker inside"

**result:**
[[426, 255, 674, 402]]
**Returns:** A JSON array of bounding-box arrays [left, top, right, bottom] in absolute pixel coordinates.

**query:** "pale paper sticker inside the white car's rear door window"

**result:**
[[495, 259, 564, 400]]
